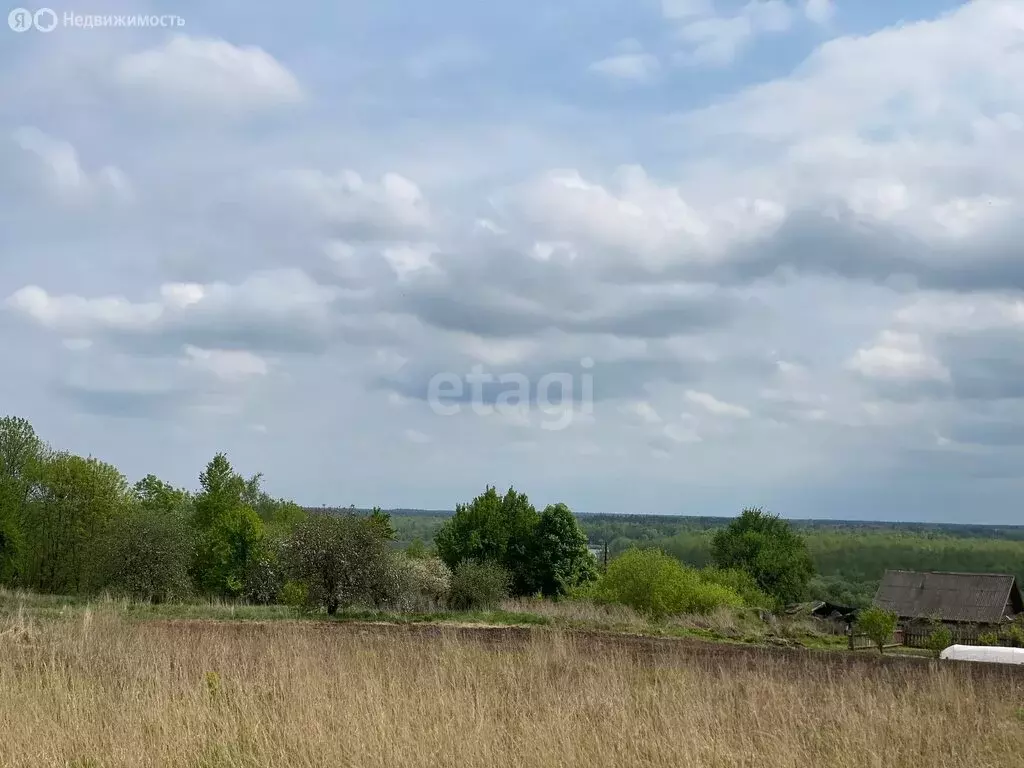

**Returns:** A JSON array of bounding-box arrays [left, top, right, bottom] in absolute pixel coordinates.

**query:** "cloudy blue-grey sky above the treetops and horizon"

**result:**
[[0, 0, 1024, 523]]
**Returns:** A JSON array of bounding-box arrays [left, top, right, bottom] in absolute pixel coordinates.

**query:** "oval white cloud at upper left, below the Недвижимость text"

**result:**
[[115, 35, 303, 114]]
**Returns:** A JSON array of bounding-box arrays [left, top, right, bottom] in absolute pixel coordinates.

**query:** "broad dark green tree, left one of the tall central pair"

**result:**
[[434, 486, 540, 595]]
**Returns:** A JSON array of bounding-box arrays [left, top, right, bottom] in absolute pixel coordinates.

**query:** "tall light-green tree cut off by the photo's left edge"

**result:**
[[0, 416, 46, 581]]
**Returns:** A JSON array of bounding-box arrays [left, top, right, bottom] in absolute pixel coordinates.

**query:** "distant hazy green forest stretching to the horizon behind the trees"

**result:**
[[309, 508, 1024, 606]]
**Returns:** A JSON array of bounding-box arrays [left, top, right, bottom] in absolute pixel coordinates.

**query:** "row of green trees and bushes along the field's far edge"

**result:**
[[0, 417, 814, 616]]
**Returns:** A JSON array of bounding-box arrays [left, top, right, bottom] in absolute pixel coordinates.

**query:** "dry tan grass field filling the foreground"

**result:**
[[0, 609, 1024, 768]]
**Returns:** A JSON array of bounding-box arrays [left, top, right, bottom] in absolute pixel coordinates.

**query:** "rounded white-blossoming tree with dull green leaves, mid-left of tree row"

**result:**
[[283, 514, 390, 615]]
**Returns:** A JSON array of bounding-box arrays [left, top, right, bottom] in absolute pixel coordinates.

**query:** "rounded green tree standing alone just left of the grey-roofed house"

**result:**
[[711, 507, 814, 603]]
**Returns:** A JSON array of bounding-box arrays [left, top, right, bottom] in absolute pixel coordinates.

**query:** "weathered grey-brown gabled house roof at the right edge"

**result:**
[[874, 570, 1024, 624]]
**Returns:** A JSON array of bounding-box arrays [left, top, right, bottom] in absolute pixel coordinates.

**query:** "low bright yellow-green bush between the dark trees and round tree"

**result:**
[[589, 549, 743, 620]]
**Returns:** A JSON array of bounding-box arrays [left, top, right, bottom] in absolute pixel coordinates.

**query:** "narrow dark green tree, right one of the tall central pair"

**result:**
[[534, 504, 597, 597]]
